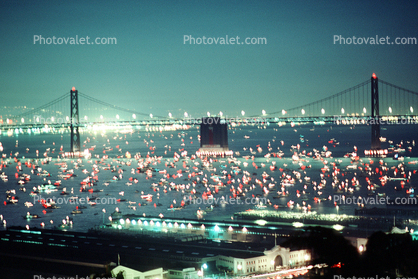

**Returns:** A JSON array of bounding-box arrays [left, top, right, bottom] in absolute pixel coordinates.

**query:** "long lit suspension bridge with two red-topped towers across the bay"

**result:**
[[0, 74, 418, 151]]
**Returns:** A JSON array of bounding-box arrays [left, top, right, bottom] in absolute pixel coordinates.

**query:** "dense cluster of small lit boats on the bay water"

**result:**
[[0, 127, 416, 232]]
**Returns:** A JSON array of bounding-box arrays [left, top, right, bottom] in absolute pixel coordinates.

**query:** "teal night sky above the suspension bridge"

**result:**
[[0, 0, 418, 117]]
